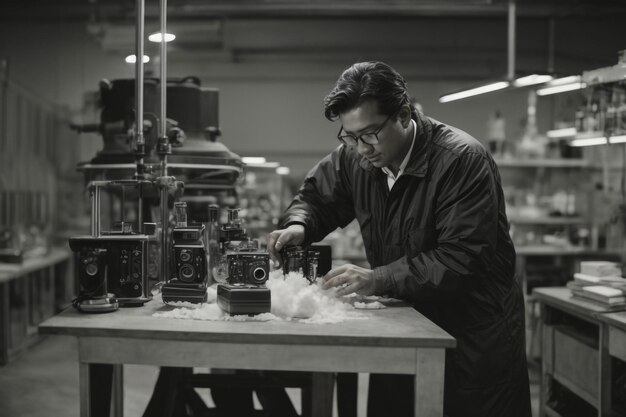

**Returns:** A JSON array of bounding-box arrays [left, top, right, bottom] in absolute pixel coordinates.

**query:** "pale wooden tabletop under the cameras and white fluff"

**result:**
[[39, 300, 456, 348]]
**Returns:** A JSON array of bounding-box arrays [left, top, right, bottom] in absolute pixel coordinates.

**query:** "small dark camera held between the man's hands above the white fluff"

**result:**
[[281, 245, 332, 283]]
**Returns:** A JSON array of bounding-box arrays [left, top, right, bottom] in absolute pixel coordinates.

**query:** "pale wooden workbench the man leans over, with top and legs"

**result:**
[[39, 301, 456, 417]]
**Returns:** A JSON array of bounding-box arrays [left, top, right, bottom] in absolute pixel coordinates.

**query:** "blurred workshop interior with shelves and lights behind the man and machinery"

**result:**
[[0, 0, 626, 416]]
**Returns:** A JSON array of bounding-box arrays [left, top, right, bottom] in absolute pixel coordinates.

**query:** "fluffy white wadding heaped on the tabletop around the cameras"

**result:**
[[153, 270, 370, 324]]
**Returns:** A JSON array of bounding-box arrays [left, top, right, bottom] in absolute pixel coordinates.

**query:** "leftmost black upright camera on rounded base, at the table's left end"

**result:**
[[72, 246, 119, 313]]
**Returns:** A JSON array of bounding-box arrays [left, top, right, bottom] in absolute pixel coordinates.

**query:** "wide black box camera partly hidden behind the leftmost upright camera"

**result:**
[[69, 223, 156, 306]]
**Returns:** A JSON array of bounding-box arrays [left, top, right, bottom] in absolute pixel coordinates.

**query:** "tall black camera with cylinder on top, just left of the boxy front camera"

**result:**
[[161, 225, 208, 303]]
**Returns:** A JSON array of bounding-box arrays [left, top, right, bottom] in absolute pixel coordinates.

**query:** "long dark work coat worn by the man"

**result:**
[[281, 115, 530, 417]]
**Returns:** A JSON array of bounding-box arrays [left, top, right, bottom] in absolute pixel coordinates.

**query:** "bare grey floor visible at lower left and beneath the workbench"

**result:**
[[0, 336, 539, 417]]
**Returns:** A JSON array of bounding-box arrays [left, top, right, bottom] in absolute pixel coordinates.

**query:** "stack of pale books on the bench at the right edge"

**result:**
[[567, 261, 626, 310]]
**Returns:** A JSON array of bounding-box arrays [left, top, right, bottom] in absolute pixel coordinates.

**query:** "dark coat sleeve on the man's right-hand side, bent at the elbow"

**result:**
[[374, 153, 499, 299]]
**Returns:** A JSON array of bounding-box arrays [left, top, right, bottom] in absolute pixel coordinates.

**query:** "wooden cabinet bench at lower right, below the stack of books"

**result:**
[[533, 287, 626, 417]]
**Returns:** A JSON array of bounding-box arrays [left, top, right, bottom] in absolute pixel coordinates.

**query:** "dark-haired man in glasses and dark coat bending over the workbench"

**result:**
[[267, 62, 531, 417]]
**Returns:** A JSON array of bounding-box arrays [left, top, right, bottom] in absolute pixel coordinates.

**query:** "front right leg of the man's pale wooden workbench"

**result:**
[[415, 348, 446, 417]]
